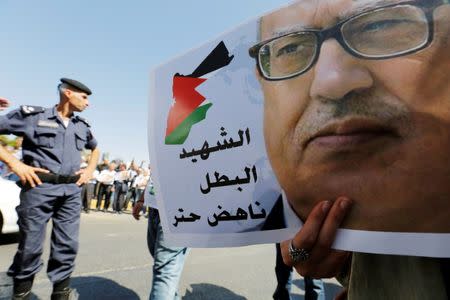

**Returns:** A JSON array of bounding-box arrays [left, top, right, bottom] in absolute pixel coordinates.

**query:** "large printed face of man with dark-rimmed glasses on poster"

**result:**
[[254, 0, 450, 232]]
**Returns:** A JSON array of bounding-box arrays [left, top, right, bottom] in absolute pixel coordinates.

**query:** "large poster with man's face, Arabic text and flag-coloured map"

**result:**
[[149, 0, 450, 257]]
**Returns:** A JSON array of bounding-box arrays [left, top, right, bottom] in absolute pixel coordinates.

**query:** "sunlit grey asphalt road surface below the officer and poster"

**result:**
[[0, 212, 339, 300]]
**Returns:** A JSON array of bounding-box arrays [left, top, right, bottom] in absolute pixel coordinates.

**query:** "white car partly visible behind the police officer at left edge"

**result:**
[[0, 177, 20, 234]]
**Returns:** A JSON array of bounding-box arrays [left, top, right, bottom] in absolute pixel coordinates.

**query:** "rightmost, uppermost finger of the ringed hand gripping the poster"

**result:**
[[314, 197, 352, 251]]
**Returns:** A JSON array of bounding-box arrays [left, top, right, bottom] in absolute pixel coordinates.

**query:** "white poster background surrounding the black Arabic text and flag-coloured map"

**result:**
[[149, 21, 304, 246]]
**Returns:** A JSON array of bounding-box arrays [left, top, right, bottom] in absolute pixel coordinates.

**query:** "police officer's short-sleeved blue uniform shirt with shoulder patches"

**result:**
[[0, 106, 97, 175]]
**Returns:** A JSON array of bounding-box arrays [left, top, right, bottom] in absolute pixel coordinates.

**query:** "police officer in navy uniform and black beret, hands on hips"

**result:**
[[0, 78, 99, 300]]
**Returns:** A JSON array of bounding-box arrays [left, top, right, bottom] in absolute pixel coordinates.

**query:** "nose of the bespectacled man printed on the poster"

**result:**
[[310, 39, 373, 100]]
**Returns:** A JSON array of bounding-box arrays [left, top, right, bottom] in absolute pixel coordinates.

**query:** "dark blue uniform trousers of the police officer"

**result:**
[[8, 183, 81, 283]]
